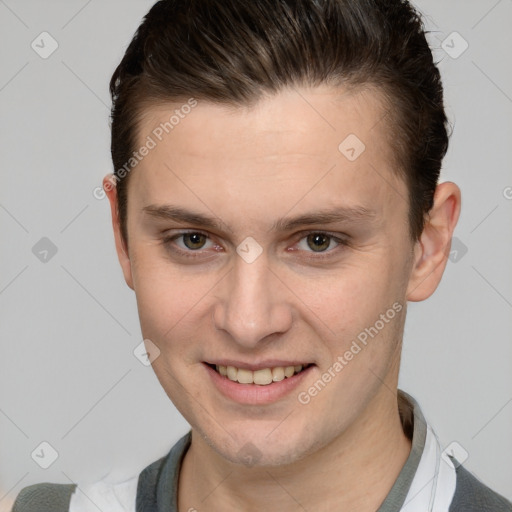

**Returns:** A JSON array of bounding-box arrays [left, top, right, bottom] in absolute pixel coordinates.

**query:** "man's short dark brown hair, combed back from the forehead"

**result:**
[[110, 0, 448, 242]]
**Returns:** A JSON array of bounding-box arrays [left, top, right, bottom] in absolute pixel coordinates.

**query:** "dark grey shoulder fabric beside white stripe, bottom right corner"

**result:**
[[449, 465, 512, 512]]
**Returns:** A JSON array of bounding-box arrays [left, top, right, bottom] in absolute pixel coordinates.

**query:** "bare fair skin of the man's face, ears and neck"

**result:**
[[104, 86, 460, 512]]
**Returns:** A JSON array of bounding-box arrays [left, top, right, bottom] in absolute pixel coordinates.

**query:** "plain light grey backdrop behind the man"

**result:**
[[0, 0, 512, 510]]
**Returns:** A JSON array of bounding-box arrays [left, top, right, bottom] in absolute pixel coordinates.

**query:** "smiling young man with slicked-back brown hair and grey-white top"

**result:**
[[13, 0, 512, 512]]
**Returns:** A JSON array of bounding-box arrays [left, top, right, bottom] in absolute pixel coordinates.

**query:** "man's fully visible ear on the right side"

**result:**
[[406, 181, 461, 302]]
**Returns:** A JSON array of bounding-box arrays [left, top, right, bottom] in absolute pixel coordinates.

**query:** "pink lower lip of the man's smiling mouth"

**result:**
[[203, 363, 314, 405]]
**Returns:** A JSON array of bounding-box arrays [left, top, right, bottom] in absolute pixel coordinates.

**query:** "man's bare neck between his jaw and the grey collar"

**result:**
[[178, 386, 411, 512]]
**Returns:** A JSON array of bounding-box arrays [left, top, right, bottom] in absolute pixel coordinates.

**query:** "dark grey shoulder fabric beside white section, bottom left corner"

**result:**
[[12, 483, 77, 512]]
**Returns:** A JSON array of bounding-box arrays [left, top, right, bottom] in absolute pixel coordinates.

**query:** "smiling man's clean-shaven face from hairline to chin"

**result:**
[[109, 88, 420, 464]]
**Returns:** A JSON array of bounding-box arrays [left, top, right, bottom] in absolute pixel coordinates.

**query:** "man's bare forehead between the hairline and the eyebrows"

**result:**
[[129, 87, 406, 231]]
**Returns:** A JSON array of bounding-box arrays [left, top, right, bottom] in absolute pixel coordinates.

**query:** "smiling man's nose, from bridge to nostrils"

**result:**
[[213, 253, 292, 348]]
